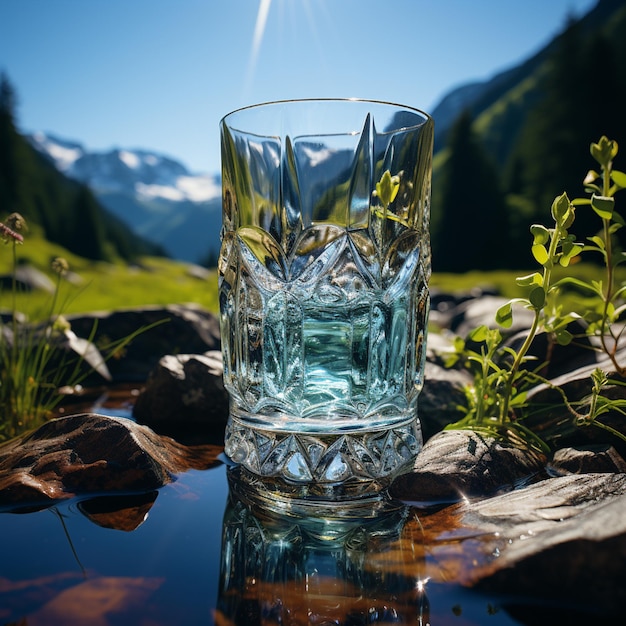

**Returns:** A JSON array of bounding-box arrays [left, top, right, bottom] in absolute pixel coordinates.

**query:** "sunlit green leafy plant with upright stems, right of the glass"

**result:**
[[447, 137, 626, 451]]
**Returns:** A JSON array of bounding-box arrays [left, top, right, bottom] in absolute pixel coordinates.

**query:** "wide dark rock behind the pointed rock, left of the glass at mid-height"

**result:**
[[66, 304, 221, 384]]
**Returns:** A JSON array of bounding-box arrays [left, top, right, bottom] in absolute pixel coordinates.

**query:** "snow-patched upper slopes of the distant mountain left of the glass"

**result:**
[[29, 132, 220, 202]]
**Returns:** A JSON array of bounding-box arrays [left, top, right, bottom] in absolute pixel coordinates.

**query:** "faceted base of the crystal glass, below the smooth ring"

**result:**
[[225, 411, 422, 501]]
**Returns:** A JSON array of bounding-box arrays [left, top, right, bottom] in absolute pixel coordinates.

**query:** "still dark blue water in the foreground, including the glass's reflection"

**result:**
[[0, 392, 604, 626]]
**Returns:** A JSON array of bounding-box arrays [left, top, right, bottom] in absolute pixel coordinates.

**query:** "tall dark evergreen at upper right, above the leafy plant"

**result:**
[[507, 16, 626, 241]]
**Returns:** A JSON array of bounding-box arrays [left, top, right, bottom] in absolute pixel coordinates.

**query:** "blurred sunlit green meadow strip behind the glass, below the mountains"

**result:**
[[0, 225, 626, 320]]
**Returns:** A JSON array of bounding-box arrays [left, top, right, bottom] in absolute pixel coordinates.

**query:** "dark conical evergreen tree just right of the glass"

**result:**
[[431, 112, 516, 272]]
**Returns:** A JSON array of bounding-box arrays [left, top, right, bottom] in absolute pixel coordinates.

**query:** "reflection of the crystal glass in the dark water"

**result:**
[[216, 468, 429, 625]]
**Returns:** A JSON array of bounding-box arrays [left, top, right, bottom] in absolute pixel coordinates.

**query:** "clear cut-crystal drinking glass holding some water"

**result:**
[[219, 99, 433, 498]]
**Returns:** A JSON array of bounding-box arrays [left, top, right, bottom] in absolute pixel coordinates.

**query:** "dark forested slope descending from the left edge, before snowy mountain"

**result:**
[[0, 76, 163, 261]]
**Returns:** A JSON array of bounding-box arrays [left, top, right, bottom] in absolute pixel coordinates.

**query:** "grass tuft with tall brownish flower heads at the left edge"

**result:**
[[0, 213, 165, 441]]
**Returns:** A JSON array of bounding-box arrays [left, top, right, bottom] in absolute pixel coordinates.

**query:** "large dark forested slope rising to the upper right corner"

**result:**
[[432, 0, 626, 272]]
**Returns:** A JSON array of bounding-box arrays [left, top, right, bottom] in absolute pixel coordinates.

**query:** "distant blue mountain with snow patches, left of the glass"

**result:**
[[28, 132, 222, 263]]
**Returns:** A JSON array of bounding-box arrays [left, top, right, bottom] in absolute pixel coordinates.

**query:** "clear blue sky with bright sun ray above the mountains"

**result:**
[[0, 0, 596, 173]]
